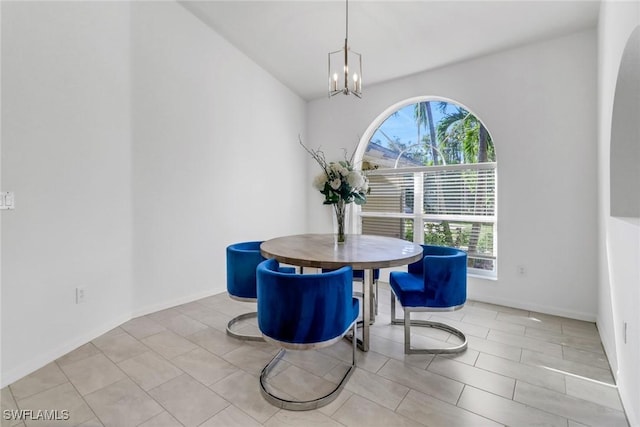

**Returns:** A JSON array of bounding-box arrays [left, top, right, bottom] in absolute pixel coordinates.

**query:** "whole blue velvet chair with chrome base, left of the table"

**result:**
[[227, 241, 294, 341]]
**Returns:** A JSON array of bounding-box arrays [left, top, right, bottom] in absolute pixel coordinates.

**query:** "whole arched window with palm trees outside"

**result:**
[[358, 98, 497, 276]]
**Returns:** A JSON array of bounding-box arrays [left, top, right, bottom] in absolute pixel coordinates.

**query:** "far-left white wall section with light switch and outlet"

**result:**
[[1, 1, 133, 385]]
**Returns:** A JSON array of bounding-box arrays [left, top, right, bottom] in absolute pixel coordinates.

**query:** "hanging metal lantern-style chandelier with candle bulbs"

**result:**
[[329, 0, 362, 98]]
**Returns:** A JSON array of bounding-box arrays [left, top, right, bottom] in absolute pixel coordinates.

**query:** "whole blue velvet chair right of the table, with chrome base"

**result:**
[[389, 245, 467, 354]]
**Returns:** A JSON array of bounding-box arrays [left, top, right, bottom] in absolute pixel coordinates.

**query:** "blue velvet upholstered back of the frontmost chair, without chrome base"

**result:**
[[257, 259, 359, 344]]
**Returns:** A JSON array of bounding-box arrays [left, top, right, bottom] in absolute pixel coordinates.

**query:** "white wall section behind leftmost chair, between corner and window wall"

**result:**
[[132, 2, 306, 313]]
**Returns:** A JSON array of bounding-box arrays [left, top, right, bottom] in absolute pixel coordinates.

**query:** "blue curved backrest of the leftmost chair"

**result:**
[[227, 242, 265, 300]]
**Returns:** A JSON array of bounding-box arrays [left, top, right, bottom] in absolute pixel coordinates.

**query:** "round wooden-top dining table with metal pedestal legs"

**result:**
[[260, 234, 422, 351]]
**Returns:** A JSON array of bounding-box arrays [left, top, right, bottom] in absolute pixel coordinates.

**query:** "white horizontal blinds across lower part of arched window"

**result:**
[[360, 163, 497, 271]]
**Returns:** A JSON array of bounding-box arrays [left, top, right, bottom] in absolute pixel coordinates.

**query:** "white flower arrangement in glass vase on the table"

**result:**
[[299, 139, 369, 243]]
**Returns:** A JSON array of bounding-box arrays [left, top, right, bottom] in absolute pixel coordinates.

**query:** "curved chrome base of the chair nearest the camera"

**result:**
[[260, 322, 358, 411]]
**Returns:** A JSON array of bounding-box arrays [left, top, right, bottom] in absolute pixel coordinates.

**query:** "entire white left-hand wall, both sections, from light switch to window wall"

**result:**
[[1, 1, 307, 386]]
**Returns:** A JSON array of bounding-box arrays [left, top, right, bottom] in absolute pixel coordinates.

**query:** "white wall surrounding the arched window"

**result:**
[[306, 30, 597, 320]]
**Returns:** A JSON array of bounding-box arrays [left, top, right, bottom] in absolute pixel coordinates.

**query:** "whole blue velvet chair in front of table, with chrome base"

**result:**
[[257, 259, 359, 411]]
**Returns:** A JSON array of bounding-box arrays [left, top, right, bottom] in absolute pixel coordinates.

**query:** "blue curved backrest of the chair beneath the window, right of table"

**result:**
[[408, 245, 467, 307]]
